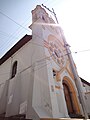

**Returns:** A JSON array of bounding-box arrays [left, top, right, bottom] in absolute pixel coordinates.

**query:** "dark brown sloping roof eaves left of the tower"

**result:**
[[0, 35, 32, 65]]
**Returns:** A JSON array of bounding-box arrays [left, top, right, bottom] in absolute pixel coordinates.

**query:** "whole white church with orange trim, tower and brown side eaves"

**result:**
[[0, 5, 90, 120]]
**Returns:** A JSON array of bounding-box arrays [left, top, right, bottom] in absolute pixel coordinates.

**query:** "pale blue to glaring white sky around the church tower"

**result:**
[[0, 0, 90, 82]]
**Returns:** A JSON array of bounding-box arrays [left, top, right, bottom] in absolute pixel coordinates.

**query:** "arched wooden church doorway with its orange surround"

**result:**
[[63, 77, 81, 115]]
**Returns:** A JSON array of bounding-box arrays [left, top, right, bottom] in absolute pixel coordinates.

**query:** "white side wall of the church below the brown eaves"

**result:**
[[0, 42, 33, 116]]
